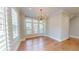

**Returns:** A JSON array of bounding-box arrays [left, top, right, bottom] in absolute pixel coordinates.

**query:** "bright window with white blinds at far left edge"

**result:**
[[0, 7, 7, 51]]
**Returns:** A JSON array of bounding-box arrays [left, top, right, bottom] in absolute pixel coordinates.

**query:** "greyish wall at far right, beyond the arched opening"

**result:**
[[70, 15, 79, 38]]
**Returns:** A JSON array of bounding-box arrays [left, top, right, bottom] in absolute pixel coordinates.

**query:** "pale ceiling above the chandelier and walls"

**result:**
[[18, 7, 79, 17]]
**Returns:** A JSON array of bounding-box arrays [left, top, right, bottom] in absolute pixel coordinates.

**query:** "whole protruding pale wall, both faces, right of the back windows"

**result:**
[[47, 12, 69, 41]]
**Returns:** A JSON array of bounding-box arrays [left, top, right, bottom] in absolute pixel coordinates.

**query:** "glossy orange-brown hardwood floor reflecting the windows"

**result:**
[[17, 37, 79, 51]]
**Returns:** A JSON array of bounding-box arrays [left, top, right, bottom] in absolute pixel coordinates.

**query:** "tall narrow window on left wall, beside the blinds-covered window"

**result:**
[[12, 8, 19, 39]]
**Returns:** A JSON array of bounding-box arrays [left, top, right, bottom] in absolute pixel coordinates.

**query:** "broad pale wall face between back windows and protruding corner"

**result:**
[[47, 13, 61, 40]]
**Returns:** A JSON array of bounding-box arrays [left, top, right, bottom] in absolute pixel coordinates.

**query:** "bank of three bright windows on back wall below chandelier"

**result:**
[[25, 18, 45, 34]]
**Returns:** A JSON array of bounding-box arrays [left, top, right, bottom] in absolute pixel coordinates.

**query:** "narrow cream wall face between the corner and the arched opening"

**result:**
[[61, 12, 70, 40]]
